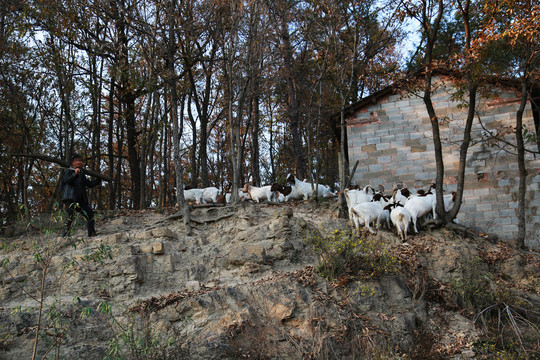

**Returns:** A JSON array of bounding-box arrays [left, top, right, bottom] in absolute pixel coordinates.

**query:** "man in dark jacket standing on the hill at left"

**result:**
[[62, 155, 101, 236]]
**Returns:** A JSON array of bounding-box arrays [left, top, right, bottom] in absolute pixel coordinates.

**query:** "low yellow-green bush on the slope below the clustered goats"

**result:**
[[307, 229, 399, 283]]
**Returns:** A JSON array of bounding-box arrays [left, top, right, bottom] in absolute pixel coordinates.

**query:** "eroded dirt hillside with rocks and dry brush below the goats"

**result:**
[[0, 201, 540, 359]]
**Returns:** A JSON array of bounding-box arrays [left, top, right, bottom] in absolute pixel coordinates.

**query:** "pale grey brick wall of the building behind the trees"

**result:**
[[345, 75, 540, 247]]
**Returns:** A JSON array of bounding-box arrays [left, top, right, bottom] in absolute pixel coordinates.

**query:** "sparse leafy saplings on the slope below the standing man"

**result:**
[[1, 208, 103, 359]]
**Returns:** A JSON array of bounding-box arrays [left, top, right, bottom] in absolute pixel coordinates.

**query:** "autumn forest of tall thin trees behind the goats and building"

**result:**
[[0, 0, 540, 231]]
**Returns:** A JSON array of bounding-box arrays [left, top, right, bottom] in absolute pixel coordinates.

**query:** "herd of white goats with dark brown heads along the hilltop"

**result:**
[[184, 174, 456, 240]]
